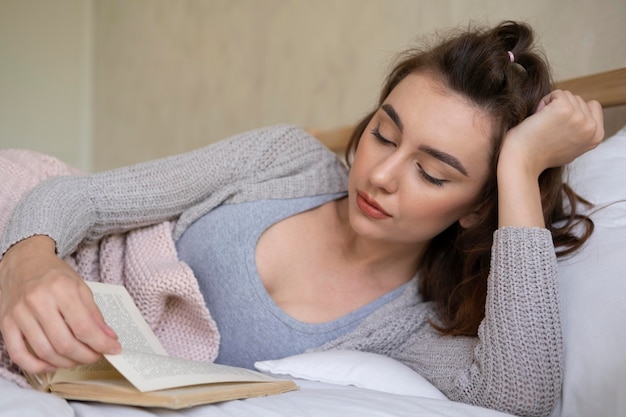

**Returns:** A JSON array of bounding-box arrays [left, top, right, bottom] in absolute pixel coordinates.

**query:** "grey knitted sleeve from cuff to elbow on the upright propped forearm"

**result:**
[[420, 227, 563, 416]]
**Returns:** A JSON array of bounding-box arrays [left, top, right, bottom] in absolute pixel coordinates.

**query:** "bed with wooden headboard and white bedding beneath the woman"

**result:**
[[0, 68, 626, 417]]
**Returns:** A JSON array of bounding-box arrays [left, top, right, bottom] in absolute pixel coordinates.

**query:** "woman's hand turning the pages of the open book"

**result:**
[[0, 236, 121, 373]]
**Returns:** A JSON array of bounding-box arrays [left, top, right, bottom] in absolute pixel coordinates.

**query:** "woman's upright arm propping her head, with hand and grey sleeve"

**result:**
[[442, 91, 604, 415]]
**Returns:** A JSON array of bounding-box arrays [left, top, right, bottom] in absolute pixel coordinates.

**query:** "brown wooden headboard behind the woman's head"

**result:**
[[309, 68, 626, 153]]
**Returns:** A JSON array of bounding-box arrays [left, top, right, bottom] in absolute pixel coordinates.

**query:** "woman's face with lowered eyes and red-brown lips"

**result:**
[[348, 73, 492, 249]]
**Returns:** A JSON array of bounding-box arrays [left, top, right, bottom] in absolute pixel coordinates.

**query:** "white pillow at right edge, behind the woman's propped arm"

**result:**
[[553, 128, 626, 417]]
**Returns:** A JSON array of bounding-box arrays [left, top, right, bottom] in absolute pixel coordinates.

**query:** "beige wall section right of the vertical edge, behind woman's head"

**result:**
[[94, 0, 626, 169]]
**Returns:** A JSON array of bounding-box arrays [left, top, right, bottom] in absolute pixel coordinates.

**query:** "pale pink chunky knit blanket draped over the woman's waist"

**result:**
[[0, 150, 219, 387]]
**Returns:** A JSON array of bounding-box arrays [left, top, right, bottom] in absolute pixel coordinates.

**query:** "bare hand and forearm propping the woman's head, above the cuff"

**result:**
[[497, 90, 604, 227]]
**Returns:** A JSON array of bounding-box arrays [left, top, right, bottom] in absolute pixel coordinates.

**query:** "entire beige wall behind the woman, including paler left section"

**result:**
[[0, 0, 626, 170]]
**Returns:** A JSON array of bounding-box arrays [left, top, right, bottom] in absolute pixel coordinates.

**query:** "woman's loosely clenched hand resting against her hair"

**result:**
[[500, 90, 604, 177]]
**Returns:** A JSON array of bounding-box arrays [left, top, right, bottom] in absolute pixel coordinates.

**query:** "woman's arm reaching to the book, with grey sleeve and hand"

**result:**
[[0, 126, 343, 372]]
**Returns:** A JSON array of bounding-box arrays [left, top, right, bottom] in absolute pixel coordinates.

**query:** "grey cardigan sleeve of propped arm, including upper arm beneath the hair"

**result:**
[[315, 227, 563, 416]]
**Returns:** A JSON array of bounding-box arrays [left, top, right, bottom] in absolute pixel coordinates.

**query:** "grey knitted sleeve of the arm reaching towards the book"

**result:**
[[0, 125, 345, 257]]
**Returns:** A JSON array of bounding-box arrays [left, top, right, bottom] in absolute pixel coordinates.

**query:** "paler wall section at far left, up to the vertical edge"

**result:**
[[0, 0, 92, 169]]
